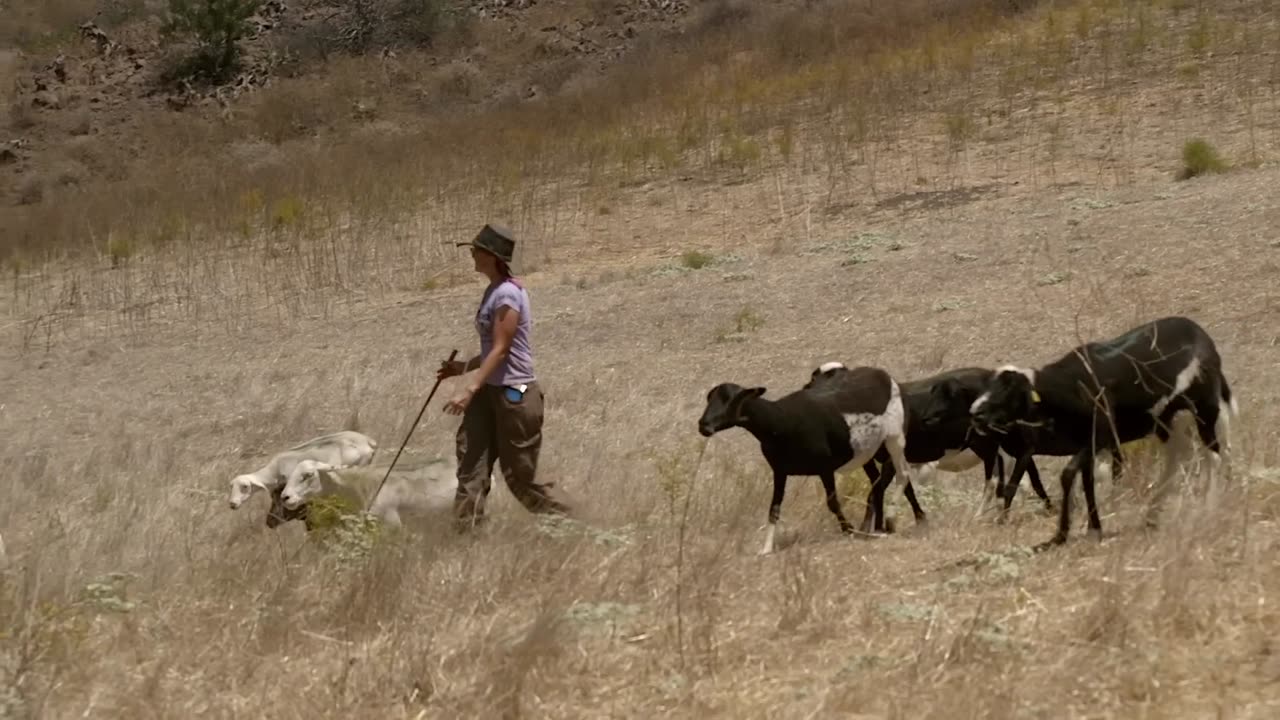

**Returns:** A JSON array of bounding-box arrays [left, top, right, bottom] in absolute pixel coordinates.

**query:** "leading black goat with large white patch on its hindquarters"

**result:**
[[698, 363, 911, 555]]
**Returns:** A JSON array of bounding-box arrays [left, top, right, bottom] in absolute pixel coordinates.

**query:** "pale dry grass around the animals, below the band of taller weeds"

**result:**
[[0, 156, 1280, 717]]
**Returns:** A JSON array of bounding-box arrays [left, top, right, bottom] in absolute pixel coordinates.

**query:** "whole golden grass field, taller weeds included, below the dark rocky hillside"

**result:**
[[0, 0, 1280, 720]]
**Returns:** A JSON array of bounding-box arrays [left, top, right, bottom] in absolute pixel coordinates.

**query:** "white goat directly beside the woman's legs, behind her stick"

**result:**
[[280, 456, 458, 527]]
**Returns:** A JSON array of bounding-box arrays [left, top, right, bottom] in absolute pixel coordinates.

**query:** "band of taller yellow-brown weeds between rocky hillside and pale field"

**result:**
[[6, 0, 1280, 274]]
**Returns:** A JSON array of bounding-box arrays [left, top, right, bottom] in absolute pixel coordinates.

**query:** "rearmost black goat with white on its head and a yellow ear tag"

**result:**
[[972, 316, 1236, 550]]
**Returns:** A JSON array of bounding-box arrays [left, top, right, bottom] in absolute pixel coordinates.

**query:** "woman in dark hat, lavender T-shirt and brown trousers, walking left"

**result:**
[[436, 224, 570, 530]]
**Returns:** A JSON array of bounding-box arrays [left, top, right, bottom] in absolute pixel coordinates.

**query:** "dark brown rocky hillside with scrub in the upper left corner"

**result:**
[[0, 0, 711, 206]]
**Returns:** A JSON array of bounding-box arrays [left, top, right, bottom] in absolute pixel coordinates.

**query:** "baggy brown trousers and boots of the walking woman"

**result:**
[[453, 382, 571, 530]]
